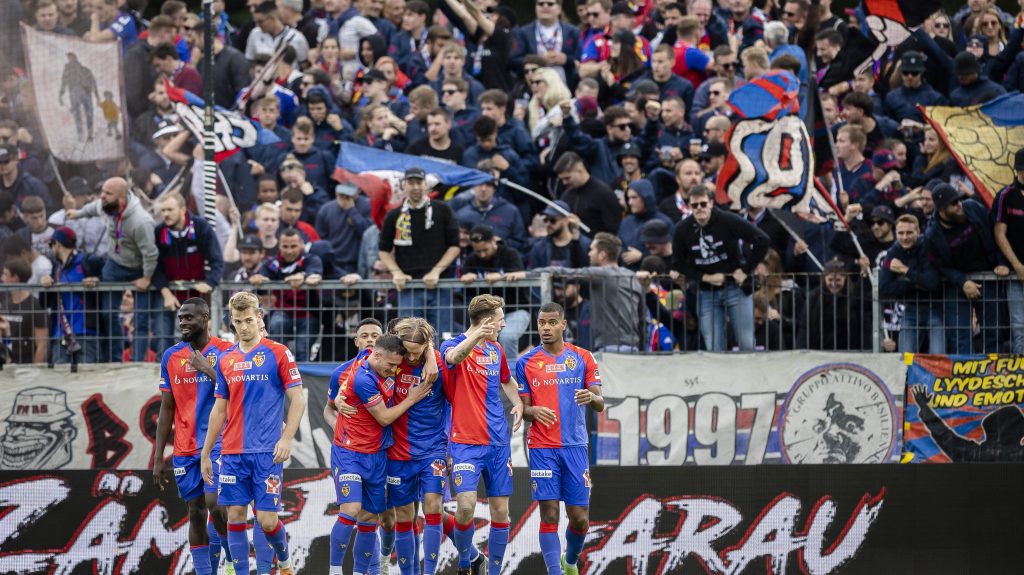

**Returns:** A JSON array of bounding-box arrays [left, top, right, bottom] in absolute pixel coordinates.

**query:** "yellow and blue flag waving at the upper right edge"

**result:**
[[922, 92, 1024, 206]]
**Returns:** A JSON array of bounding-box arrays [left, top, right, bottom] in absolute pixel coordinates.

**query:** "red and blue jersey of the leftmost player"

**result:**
[[160, 338, 231, 456]]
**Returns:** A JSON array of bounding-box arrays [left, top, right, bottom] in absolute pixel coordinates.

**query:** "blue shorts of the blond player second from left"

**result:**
[[217, 453, 285, 512]]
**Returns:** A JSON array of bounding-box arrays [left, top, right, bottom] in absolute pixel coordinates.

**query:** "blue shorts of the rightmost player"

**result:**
[[529, 445, 591, 507]]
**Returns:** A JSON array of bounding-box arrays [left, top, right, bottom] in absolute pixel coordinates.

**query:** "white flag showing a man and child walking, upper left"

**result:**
[[22, 25, 127, 163]]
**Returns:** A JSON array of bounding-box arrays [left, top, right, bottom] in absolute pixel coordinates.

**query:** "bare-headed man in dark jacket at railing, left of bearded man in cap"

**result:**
[[879, 214, 946, 355]]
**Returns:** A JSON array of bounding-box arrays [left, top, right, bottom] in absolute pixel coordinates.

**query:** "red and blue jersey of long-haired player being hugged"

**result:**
[[387, 351, 449, 461]]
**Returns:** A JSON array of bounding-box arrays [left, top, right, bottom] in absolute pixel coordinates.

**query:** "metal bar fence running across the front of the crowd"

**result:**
[[0, 270, 1024, 364]]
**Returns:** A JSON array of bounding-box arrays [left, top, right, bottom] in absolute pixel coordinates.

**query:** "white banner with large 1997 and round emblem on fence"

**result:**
[[595, 352, 905, 466]]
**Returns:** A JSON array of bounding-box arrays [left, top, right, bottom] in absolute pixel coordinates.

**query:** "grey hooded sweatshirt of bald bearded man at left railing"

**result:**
[[78, 193, 160, 278]]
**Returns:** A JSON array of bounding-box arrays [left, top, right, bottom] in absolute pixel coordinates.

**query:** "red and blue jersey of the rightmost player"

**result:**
[[515, 344, 601, 447]]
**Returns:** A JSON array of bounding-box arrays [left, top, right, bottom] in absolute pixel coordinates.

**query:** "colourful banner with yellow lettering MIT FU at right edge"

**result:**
[[903, 355, 1024, 463]]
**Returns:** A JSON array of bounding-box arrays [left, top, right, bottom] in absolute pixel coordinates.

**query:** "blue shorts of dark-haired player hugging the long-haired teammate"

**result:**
[[331, 444, 388, 514]]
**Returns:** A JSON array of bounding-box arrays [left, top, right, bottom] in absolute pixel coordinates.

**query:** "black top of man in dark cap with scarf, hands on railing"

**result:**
[[380, 200, 459, 279]]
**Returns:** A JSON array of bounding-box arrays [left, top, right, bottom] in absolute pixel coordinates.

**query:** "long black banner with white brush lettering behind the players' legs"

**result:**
[[0, 465, 1024, 575]]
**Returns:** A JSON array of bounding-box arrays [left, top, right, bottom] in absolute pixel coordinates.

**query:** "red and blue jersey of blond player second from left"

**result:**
[[216, 338, 302, 454]]
